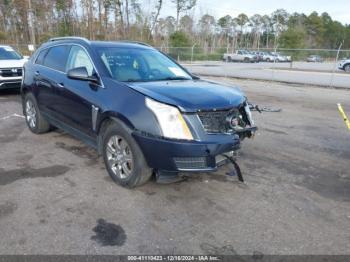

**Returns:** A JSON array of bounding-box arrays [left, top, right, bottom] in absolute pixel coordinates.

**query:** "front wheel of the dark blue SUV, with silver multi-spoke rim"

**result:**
[[102, 120, 152, 188]]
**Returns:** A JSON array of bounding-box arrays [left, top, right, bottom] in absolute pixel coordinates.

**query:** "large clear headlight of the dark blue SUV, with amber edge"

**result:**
[[146, 97, 193, 140]]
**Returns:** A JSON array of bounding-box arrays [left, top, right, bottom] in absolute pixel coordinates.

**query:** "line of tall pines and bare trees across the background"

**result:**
[[0, 0, 350, 53]]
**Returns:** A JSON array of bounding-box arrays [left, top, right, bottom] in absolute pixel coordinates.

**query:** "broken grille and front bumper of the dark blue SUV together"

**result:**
[[133, 100, 257, 180]]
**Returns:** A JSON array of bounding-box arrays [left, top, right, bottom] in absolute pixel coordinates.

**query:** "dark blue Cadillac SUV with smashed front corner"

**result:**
[[21, 37, 256, 187]]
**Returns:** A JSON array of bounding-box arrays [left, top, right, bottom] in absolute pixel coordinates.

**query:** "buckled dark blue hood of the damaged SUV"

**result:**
[[127, 80, 246, 112]]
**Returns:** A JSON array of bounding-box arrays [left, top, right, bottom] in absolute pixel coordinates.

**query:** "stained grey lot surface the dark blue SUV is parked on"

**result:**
[[0, 79, 350, 254]]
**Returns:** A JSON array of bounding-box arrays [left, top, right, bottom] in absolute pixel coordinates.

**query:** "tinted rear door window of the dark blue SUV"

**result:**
[[43, 45, 69, 72]]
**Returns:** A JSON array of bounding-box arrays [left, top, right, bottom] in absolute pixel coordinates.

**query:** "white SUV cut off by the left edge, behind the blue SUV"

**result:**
[[0, 45, 28, 89]]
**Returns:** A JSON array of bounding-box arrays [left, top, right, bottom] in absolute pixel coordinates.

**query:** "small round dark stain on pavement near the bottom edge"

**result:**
[[91, 219, 126, 246]]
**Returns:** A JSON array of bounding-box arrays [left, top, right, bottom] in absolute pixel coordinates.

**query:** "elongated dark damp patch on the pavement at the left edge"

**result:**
[[0, 165, 70, 186]]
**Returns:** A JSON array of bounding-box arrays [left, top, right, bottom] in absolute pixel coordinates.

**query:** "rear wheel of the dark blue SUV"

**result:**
[[23, 93, 51, 134]]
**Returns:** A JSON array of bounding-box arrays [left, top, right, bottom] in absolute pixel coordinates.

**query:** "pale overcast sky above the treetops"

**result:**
[[154, 0, 350, 24]]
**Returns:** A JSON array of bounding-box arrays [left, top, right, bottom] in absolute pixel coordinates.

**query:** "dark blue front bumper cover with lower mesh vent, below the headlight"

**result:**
[[133, 132, 240, 172]]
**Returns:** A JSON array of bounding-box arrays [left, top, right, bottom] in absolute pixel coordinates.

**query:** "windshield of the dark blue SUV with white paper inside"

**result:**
[[97, 47, 192, 82]]
